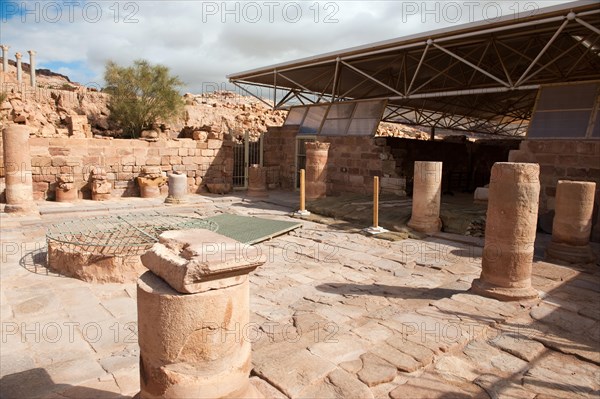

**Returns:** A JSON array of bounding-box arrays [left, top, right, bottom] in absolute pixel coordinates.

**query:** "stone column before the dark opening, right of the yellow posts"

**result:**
[[408, 161, 442, 233]]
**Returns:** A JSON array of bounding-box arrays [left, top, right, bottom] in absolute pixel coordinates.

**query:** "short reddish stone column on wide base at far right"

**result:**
[[546, 180, 596, 263]]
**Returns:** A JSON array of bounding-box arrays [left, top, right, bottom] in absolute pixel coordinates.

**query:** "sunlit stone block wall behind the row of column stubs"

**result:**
[[25, 137, 233, 200]]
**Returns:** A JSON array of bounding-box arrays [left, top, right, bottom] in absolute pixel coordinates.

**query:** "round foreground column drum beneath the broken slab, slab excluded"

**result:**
[[137, 272, 253, 398]]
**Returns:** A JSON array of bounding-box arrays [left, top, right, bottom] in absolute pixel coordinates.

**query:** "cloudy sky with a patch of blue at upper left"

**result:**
[[0, 0, 580, 93]]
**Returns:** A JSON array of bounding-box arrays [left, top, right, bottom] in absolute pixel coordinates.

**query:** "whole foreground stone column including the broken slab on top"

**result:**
[[137, 229, 264, 399]]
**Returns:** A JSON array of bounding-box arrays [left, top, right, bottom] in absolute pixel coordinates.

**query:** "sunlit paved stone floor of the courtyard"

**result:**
[[0, 193, 600, 399]]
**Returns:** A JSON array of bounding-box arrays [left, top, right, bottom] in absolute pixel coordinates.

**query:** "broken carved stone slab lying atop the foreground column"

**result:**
[[141, 229, 264, 293]]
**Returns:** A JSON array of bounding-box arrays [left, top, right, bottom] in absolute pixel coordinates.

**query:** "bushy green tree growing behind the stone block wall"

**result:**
[[104, 60, 183, 137]]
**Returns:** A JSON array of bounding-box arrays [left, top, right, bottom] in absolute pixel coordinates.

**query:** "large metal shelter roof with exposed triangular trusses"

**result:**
[[227, 1, 600, 135]]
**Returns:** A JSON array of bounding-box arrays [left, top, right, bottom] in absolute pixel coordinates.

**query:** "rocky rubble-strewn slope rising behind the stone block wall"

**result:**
[[0, 63, 428, 139]]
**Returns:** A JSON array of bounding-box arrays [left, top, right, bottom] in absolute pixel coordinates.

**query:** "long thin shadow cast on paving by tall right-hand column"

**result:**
[[316, 283, 465, 300]]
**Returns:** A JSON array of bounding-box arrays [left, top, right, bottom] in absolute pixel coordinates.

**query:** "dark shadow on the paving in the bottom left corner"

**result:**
[[0, 368, 130, 399]]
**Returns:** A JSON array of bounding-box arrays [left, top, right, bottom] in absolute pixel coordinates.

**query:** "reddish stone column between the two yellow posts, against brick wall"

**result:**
[[306, 141, 330, 199]]
